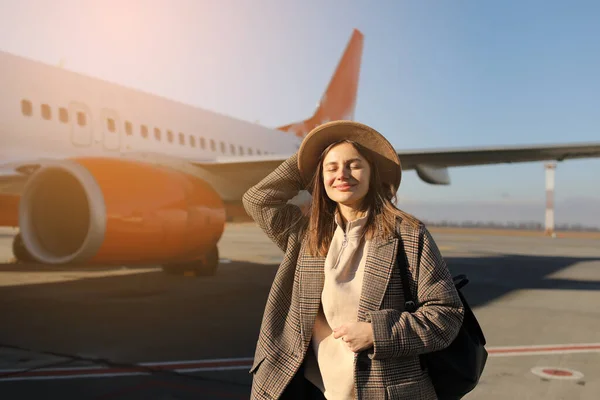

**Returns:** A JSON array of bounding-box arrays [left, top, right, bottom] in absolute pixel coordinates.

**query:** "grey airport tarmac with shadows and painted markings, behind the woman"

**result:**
[[0, 223, 600, 400]]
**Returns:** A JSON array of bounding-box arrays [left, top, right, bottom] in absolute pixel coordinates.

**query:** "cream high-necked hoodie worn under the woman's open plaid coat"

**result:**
[[304, 213, 368, 400]]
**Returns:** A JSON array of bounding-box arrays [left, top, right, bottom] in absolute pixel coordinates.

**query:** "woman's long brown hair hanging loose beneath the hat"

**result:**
[[306, 139, 420, 256]]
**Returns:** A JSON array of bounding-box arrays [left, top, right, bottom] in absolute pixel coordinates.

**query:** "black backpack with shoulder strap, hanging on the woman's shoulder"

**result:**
[[397, 241, 488, 400]]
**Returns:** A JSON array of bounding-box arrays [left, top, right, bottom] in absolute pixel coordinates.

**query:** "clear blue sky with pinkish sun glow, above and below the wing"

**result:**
[[0, 0, 600, 208]]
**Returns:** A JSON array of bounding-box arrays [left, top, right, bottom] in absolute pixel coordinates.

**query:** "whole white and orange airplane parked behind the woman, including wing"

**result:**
[[0, 29, 600, 276]]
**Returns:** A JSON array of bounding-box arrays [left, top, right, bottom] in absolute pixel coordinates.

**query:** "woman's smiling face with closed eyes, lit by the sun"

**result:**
[[323, 143, 371, 208]]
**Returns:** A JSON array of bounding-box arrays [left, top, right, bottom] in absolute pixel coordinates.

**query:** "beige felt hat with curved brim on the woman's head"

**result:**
[[298, 120, 402, 191]]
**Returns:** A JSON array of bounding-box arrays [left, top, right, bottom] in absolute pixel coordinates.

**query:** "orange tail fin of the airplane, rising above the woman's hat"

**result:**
[[277, 29, 364, 137]]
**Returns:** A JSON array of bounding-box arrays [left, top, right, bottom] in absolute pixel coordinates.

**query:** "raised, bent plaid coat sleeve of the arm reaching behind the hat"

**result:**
[[242, 153, 306, 252]]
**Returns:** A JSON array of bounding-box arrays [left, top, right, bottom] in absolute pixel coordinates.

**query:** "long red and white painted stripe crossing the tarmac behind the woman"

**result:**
[[0, 343, 600, 382]]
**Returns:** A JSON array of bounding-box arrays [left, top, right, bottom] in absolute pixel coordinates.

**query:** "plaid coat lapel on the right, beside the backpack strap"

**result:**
[[358, 237, 398, 321]]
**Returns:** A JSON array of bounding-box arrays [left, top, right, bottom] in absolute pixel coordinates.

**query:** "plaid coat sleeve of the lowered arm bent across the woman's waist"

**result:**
[[367, 227, 464, 359]]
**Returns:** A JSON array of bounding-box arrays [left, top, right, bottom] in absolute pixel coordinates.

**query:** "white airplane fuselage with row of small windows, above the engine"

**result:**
[[0, 52, 300, 169]]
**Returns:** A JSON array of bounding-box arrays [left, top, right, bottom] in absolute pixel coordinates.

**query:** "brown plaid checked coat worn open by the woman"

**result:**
[[243, 154, 463, 400]]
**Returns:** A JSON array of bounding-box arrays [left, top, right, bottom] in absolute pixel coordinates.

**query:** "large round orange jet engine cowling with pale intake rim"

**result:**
[[19, 158, 225, 264]]
